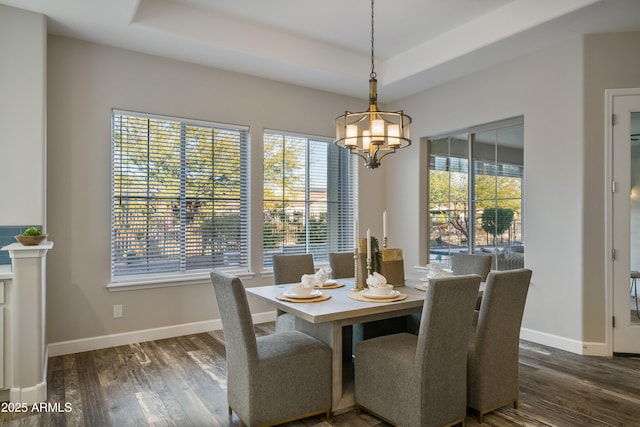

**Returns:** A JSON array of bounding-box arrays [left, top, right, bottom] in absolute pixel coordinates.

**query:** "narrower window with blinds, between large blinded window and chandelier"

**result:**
[[263, 132, 356, 267]]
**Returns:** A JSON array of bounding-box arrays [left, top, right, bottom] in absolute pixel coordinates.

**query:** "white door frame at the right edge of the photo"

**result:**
[[604, 88, 640, 356]]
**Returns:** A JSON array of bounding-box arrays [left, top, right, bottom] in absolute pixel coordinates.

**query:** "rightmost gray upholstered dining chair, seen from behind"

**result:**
[[467, 268, 531, 423]]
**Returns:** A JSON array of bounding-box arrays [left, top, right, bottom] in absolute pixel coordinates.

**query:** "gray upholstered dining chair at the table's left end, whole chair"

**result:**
[[211, 270, 331, 427]]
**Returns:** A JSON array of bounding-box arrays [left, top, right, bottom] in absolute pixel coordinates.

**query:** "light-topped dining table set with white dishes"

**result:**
[[247, 278, 426, 414]]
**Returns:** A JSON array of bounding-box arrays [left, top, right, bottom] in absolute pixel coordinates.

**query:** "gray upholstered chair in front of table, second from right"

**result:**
[[355, 275, 480, 427]]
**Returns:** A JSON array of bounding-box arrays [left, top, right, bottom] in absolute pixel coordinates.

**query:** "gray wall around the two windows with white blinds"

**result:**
[[47, 37, 384, 343]]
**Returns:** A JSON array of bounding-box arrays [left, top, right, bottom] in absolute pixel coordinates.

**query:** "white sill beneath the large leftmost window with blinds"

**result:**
[[107, 270, 255, 292]]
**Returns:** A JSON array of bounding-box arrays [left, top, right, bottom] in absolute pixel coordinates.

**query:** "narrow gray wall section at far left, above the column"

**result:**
[[0, 5, 47, 226]]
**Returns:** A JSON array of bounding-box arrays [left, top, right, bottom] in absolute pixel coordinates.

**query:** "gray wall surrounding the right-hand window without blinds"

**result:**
[[386, 39, 588, 344]]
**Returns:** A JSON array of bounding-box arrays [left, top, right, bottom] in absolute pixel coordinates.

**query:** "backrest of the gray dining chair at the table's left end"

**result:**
[[211, 270, 258, 370]]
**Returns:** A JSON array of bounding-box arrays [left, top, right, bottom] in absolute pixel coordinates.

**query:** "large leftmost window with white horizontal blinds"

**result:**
[[111, 111, 248, 280]]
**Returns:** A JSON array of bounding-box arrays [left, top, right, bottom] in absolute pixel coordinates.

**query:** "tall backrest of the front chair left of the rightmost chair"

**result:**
[[415, 275, 480, 425]]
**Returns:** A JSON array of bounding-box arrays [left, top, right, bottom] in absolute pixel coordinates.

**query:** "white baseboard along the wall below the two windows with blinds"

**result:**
[[47, 311, 276, 357]]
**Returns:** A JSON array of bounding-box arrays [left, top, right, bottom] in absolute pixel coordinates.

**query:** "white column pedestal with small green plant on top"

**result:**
[[2, 241, 53, 404]]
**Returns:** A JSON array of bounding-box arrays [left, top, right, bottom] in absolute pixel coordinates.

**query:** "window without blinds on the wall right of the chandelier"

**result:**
[[428, 118, 524, 270]]
